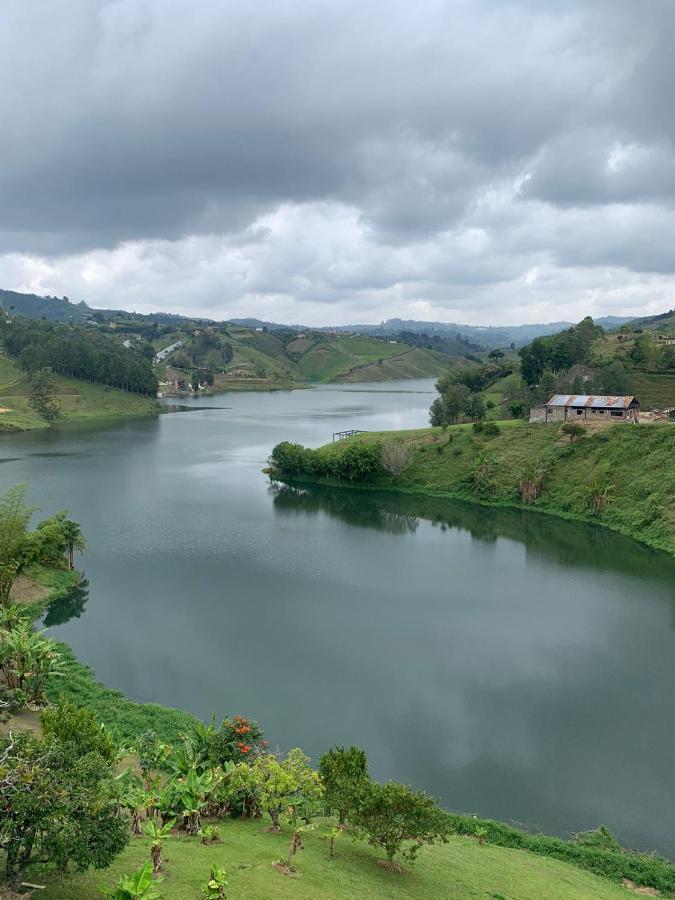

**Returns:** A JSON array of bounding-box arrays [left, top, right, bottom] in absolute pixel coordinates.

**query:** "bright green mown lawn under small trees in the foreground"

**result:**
[[37, 820, 630, 900]]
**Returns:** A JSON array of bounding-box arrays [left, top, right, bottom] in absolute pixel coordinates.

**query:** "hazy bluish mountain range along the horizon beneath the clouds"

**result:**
[[0, 290, 644, 349]]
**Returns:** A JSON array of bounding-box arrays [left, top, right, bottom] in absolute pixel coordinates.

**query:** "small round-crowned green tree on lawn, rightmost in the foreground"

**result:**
[[354, 782, 451, 870]]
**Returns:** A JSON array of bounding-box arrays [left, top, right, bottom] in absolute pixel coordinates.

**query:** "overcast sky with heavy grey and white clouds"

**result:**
[[0, 0, 675, 324]]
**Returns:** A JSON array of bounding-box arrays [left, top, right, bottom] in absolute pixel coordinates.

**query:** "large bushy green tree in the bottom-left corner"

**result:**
[[0, 716, 129, 886]]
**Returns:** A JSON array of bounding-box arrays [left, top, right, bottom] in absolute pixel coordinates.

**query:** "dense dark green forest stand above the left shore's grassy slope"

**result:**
[[0, 315, 157, 396]]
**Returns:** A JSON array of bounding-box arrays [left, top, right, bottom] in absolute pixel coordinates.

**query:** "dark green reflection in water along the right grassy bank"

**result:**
[[271, 474, 675, 587]]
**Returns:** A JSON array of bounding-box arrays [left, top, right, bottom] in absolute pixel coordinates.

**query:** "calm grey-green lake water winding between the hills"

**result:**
[[0, 381, 675, 856]]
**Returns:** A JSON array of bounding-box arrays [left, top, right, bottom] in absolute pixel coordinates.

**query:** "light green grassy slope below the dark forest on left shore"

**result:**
[[0, 356, 155, 432]]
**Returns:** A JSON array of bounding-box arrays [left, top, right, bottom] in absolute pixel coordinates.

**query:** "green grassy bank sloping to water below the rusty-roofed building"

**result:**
[[278, 420, 675, 555]]
